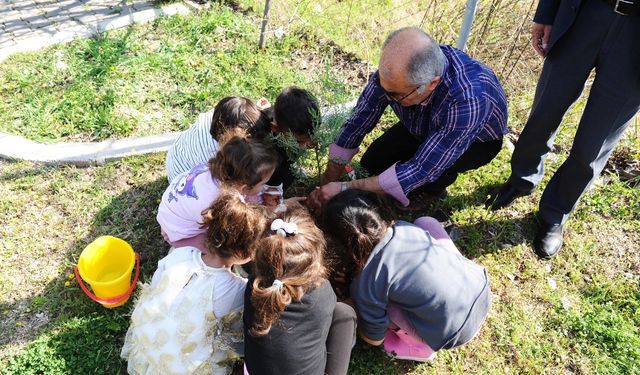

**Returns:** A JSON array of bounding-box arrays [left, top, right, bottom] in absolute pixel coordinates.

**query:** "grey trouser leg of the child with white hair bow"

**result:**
[[324, 302, 358, 375]]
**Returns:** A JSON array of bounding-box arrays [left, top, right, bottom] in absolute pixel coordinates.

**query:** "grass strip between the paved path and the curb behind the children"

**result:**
[[0, 5, 356, 141]]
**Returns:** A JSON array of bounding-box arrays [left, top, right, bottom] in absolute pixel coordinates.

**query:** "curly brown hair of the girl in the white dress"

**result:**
[[202, 191, 270, 259]]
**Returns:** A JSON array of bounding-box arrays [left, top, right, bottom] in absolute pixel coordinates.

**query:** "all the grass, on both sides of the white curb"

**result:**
[[0, 1, 640, 375]]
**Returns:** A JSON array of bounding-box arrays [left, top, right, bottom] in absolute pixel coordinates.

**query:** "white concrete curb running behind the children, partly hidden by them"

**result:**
[[0, 100, 356, 166]]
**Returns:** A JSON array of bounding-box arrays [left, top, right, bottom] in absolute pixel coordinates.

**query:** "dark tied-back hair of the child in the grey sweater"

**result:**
[[322, 189, 394, 276]]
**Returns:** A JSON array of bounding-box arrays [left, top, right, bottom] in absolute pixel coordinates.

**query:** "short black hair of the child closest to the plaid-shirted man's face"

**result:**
[[274, 86, 321, 135]]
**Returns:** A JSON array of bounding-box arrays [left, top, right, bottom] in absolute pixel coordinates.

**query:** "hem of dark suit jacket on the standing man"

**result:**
[[533, 0, 583, 51]]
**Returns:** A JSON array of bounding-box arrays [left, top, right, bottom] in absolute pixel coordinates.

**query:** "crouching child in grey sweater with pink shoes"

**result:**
[[324, 190, 491, 361]]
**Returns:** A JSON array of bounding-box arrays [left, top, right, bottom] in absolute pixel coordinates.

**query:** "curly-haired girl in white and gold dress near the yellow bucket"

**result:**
[[121, 192, 267, 374]]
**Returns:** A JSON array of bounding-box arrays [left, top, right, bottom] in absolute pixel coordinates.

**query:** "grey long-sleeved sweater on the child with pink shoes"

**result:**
[[351, 221, 491, 350]]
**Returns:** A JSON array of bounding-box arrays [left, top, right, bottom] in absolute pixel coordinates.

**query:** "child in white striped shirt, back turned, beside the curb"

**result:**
[[165, 96, 270, 181]]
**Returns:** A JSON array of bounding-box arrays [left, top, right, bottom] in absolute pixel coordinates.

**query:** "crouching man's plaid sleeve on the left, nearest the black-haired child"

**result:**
[[329, 72, 389, 161]]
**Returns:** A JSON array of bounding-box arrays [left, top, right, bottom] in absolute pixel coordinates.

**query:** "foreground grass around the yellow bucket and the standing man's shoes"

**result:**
[[0, 150, 640, 374]]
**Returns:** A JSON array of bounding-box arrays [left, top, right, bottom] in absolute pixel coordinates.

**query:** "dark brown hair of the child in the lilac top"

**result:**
[[209, 129, 279, 188]]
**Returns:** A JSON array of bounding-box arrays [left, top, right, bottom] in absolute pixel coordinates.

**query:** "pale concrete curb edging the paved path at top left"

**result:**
[[0, 3, 190, 62]]
